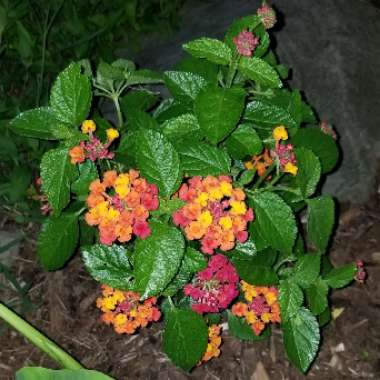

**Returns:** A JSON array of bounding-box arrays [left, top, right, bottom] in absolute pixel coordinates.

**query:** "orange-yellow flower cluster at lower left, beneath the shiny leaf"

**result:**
[[96, 285, 161, 334]]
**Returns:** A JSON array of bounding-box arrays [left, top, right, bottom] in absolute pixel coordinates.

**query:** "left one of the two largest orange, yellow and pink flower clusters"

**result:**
[[85, 169, 159, 245]]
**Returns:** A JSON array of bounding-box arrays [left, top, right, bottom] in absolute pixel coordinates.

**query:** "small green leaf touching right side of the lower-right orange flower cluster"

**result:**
[[279, 279, 303, 322]]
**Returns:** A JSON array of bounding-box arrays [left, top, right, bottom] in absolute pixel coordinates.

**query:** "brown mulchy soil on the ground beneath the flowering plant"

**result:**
[[0, 197, 380, 380]]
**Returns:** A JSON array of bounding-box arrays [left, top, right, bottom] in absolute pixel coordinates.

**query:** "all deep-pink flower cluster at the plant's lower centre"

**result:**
[[183, 255, 239, 314]]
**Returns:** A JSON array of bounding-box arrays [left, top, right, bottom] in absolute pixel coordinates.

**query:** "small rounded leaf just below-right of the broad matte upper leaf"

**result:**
[[226, 124, 263, 160]]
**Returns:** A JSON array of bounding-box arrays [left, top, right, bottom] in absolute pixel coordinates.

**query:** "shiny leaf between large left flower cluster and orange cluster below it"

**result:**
[[82, 244, 132, 290]]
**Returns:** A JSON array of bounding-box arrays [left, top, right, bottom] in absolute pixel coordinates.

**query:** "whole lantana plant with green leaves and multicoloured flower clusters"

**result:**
[[11, 5, 357, 372]]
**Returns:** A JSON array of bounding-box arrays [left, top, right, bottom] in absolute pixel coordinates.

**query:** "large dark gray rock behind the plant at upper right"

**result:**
[[122, 0, 380, 202]]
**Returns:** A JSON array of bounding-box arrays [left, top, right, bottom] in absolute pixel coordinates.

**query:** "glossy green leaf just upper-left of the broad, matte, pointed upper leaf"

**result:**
[[164, 71, 207, 103]]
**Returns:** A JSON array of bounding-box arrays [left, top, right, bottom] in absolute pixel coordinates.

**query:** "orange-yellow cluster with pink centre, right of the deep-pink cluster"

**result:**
[[231, 281, 281, 335]]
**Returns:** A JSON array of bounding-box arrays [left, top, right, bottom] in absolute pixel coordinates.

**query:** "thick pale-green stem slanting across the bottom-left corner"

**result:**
[[0, 303, 83, 369]]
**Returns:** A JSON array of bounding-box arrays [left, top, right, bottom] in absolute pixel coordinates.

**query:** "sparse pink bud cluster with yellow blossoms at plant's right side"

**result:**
[[271, 125, 298, 175]]
